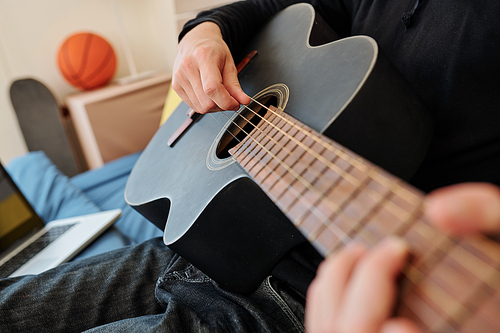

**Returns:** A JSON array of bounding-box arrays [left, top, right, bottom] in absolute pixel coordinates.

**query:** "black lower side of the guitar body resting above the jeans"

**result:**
[[169, 177, 306, 294]]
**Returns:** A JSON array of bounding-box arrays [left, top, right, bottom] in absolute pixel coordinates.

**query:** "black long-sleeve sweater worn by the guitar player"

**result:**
[[180, 0, 500, 291]]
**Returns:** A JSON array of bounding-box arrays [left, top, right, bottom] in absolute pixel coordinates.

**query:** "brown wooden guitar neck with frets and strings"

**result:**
[[230, 109, 500, 332]]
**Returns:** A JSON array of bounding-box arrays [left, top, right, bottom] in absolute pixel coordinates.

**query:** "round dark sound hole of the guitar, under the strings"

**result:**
[[216, 95, 278, 159]]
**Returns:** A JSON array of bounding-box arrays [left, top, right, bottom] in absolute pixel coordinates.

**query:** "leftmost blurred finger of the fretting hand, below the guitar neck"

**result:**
[[305, 244, 366, 332]]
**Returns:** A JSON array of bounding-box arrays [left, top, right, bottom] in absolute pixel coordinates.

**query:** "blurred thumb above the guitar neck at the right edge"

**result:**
[[425, 183, 500, 234]]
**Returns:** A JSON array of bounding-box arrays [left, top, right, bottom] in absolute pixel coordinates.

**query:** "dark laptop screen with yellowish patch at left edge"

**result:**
[[0, 164, 44, 251]]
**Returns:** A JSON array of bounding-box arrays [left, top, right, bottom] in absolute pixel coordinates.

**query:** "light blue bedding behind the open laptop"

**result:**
[[6, 151, 162, 260]]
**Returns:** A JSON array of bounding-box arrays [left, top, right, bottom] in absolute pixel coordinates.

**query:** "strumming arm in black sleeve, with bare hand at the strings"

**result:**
[[172, 0, 354, 113]]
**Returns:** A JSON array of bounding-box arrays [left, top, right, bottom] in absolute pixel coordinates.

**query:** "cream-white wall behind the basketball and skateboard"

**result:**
[[0, 0, 177, 163]]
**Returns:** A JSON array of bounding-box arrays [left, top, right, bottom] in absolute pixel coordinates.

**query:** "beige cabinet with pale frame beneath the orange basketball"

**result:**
[[65, 74, 172, 169]]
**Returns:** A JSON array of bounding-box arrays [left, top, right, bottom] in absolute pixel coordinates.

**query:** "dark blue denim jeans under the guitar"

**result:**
[[0, 238, 304, 332]]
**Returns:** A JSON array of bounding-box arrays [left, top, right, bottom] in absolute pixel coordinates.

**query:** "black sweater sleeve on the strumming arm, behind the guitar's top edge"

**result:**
[[179, 0, 352, 56]]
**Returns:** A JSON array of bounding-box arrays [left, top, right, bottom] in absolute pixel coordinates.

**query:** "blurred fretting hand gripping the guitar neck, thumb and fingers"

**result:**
[[306, 183, 500, 333]]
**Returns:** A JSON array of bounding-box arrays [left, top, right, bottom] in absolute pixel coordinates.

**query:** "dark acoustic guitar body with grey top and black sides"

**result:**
[[125, 4, 432, 293]]
